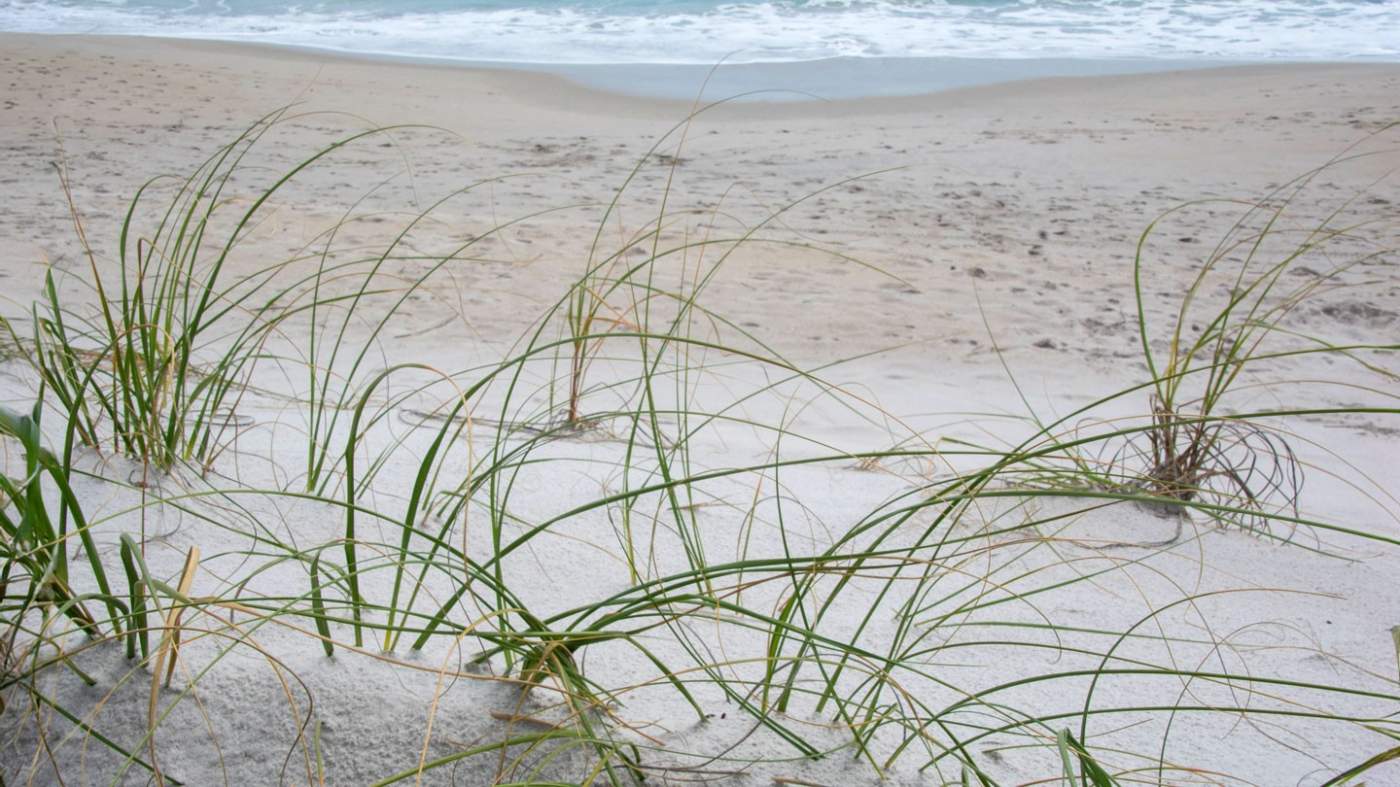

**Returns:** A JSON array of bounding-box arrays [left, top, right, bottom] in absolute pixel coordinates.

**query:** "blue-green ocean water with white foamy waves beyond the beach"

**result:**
[[0, 0, 1400, 66]]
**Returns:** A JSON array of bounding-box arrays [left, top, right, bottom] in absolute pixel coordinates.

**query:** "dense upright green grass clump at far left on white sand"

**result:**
[[7, 112, 330, 471]]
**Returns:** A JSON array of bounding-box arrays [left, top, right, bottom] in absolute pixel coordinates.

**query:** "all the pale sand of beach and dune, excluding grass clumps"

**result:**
[[0, 35, 1400, 784]]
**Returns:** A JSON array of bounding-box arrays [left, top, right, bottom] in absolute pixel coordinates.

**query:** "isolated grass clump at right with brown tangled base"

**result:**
[[1095, 140, 1396, 532]]
